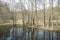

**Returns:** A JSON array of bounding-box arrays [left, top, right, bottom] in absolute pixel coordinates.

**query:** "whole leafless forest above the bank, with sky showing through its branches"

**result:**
[[0, 0, 60, 26]]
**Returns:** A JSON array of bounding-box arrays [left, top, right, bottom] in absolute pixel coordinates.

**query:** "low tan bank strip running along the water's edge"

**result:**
[[0, 23, 60, 31]]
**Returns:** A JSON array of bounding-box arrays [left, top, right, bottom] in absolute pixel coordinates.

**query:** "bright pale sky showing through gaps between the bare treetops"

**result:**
[[2, 0, 58, 9]]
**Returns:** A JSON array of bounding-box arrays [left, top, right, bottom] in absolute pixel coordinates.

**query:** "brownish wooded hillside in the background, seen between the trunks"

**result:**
[[0, 4, 60, 22]]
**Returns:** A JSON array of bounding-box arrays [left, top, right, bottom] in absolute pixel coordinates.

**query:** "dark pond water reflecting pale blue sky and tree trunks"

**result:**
[[0, 28, 60, 40]]
